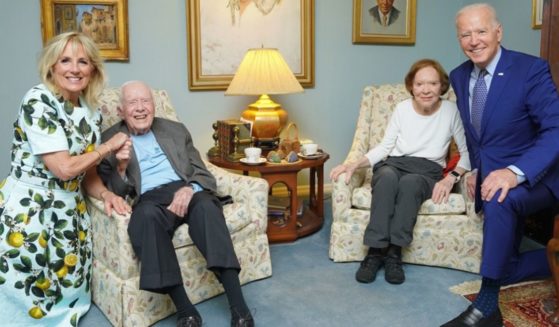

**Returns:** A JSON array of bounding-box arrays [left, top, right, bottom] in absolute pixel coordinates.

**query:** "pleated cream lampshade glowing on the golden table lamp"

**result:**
[[225, 48, 303, 95]]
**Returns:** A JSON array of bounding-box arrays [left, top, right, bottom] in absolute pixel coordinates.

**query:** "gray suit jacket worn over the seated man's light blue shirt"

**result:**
[[97, 117, 216, 203]]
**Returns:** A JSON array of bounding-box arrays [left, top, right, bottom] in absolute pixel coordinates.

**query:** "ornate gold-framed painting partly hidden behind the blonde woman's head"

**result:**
[[41, 0, 128, 61]]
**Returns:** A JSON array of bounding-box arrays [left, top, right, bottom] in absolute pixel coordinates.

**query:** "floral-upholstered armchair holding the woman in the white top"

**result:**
[[329, 84, 483, 273]]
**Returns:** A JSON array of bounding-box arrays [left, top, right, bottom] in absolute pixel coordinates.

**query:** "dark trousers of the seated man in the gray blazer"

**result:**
[[128, 182, 240, 293]]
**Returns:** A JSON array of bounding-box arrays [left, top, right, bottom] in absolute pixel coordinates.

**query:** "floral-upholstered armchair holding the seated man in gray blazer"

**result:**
[[88, 89, 272, 326]]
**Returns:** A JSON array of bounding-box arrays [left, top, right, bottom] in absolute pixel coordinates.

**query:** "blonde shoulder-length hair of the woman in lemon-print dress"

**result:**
[[39, 32, 106, 110]]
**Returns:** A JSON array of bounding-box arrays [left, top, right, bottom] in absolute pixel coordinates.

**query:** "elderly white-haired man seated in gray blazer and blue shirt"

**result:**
[[98, 81, 254, 326]]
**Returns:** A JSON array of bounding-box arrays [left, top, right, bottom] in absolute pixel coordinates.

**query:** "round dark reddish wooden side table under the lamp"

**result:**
[[208, 153, 330, 243]]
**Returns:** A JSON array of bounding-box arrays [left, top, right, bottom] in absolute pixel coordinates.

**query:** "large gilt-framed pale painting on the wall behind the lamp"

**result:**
[[186, 0, 314, 90]]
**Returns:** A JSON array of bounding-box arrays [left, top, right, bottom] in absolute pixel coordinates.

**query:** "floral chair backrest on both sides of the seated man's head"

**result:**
[[99, 88, 179, 131]]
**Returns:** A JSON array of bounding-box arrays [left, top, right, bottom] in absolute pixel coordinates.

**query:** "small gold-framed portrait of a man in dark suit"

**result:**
[[353, 0, 416, 44]]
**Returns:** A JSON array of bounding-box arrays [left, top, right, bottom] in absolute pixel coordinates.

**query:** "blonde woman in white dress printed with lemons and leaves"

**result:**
[[0, 32, 130, 326]]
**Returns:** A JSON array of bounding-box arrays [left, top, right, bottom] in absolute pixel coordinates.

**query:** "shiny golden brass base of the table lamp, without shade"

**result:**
[[241, 94, 287, 142]]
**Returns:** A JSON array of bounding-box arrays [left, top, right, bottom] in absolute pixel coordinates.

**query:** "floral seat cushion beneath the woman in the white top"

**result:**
[[351, 184, 466, 215]]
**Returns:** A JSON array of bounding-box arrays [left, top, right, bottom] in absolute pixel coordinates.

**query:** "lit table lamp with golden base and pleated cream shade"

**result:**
[[225, 48, 303, 150]]
